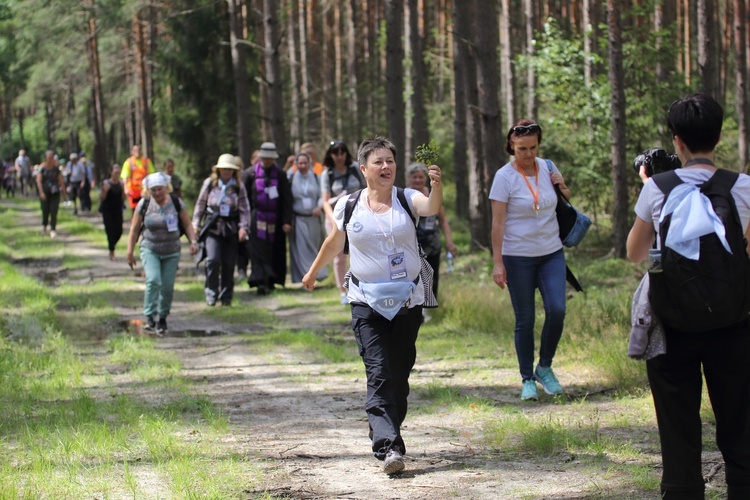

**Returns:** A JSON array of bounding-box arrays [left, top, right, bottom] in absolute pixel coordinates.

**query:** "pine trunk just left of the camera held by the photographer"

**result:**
[[607, 0, 630, 258]]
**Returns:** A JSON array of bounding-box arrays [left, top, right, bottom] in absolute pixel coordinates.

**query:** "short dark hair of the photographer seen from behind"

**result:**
[[667, 94, 724, 153]]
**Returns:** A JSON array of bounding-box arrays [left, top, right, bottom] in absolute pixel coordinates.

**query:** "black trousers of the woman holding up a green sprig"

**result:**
[[351, 303, 422, 460]]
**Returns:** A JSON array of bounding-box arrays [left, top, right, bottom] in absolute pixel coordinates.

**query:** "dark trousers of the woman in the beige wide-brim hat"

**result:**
[[205, 233, 239, 304]]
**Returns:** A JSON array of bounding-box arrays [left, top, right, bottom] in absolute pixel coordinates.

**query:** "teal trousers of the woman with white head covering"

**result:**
[[141, 247, 180, 318]]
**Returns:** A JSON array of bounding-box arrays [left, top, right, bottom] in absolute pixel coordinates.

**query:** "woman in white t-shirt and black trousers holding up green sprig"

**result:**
[[302, 137, 443, 474]]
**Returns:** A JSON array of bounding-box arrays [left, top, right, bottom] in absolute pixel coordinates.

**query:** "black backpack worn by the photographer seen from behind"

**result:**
[[649, 169, 750, 332]]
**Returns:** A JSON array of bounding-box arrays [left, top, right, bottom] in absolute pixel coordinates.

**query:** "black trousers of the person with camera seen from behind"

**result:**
[[646, 322, 750, 500]]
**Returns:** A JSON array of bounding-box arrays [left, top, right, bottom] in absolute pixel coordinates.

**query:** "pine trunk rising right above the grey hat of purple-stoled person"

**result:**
[[263, 0, 290, 157]]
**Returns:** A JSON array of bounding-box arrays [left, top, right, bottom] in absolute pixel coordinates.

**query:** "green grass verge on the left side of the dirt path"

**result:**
[[0, 198, 267, 498]]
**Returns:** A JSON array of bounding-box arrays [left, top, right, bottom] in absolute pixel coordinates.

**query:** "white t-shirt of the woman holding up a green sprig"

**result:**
[[333, 187, 424, 307]]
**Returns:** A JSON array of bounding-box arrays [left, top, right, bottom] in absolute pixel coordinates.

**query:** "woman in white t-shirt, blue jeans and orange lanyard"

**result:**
[[490, 120, 570, 400]]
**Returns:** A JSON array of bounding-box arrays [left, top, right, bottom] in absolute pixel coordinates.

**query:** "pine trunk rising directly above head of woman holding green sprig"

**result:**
[[385, 0, 406, 186]]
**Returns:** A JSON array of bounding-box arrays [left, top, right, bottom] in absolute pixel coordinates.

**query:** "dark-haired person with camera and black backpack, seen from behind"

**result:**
[[627, 94, 750, 500]]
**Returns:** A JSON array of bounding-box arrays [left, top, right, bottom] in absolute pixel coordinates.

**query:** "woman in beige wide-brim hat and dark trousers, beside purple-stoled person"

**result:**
[[193, 154, 250, 306]]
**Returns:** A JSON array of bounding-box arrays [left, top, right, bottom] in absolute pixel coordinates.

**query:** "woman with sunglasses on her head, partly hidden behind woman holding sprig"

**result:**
[[320, 141, 365, 305]]
